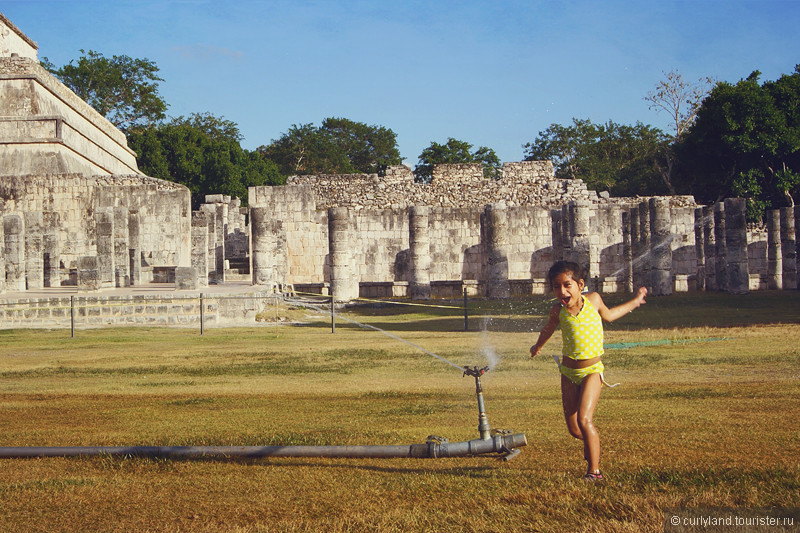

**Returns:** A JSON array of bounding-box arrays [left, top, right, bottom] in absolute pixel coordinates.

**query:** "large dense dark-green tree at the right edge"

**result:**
[[677, 66, 800, 220]]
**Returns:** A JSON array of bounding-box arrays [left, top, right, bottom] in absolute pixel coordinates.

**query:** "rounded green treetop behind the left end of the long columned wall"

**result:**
[[258, 118, 402, 176]]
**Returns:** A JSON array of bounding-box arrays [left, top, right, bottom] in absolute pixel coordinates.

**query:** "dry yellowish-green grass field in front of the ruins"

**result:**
[[0, 291, 800, 532]]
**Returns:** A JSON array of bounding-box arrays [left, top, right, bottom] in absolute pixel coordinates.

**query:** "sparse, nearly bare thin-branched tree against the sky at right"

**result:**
[[644, 70, 714, 194]]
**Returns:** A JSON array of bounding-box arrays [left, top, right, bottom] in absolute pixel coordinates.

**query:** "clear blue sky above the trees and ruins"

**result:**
[[0, 0, 800, 166]]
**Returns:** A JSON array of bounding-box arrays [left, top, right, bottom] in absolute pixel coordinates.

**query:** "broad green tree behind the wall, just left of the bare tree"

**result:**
[[524, 118, 669, 196]]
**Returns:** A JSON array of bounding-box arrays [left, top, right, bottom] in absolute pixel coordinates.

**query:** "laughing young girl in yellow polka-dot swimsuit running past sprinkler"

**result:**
[[531, 261, 647, 481]]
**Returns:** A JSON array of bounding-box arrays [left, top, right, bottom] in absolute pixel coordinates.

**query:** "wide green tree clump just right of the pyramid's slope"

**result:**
[[128, 113, 285, 207]]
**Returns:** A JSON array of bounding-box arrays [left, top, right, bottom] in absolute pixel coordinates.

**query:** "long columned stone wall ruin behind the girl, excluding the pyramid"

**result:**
[[249, 161, 797, 300]]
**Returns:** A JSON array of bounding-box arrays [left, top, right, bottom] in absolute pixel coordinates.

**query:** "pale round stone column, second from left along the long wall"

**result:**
[[328, 207, 359, 302]]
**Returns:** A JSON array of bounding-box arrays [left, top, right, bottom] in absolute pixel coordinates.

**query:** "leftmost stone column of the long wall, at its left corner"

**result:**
[[250, 207, 283, 289]]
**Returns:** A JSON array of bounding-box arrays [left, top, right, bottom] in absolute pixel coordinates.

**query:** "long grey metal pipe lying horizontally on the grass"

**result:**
[[0, 433, 528, 459]]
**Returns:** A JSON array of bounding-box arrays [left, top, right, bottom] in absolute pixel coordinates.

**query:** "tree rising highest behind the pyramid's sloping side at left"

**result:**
[[42, 50, 167, 130]]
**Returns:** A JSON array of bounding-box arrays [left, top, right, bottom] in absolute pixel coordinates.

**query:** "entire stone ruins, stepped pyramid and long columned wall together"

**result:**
[[0, 15, 800, 300]]
